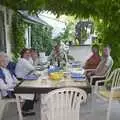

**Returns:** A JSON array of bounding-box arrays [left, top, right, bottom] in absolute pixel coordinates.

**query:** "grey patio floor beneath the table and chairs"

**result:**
[[2, 96, 120, 120]]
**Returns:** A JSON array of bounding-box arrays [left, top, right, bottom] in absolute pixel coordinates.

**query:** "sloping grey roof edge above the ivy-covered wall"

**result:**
[[18, 10, 52, 27]]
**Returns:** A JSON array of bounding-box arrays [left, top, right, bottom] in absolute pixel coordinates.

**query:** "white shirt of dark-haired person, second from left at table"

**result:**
[[15, 58, 35, 78]]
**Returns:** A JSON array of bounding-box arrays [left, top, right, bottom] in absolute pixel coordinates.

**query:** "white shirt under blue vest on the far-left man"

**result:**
[[0, 68, 17, 96]]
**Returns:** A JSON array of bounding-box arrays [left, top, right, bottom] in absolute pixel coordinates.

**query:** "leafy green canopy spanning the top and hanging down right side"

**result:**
[[0, 0, 120, 67]]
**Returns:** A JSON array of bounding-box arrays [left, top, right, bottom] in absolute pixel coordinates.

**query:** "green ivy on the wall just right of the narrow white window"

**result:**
[[32, 24, 52, 55]]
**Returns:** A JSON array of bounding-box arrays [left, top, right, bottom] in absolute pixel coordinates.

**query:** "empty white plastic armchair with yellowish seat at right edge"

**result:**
[[95, 68, 120, 120]]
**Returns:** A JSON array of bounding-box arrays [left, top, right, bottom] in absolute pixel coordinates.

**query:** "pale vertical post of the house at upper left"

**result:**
[[0, 5, 13, 56]]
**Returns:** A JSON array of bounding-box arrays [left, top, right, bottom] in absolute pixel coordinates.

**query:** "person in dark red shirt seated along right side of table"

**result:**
[[84, 46, 101, 69]]
